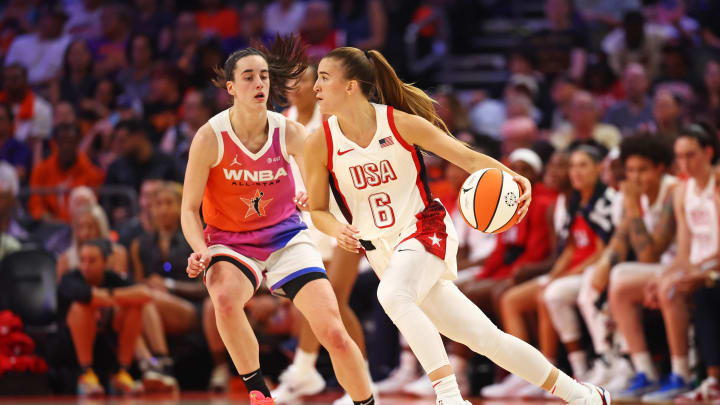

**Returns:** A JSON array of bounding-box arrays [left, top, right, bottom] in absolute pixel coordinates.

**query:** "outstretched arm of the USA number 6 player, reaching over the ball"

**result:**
[[393, 110, 531, 220]]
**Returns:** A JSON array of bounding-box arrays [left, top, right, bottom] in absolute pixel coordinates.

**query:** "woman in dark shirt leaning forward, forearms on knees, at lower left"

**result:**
[[58, 239, 150, 396]]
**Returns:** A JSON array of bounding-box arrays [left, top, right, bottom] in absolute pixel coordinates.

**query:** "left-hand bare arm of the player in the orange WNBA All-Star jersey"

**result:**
[[180, 123, 218, 277]]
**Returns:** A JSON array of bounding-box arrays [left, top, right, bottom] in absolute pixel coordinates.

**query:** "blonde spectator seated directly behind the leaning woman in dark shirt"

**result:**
[[56, 203, 128, 279]]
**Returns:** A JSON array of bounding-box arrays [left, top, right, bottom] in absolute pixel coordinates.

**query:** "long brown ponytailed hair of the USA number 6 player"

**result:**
[[325, 46, 450, 134]]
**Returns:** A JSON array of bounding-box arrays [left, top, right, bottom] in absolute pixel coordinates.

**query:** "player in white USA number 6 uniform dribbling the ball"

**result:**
[[305, 47, 610, 405]]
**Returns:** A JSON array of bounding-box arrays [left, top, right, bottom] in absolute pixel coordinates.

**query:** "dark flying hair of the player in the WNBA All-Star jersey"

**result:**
[[213, 35, 308, 109]]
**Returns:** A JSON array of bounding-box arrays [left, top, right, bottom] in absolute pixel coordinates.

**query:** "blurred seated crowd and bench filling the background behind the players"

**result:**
[[0, 0, 720, 401]]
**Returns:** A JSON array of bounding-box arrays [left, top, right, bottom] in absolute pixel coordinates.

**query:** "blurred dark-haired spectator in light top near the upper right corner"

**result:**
[[602, 11, 666, 81]]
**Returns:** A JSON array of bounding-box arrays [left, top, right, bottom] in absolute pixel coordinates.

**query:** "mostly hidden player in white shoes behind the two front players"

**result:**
[[272, 65, 367, 405]]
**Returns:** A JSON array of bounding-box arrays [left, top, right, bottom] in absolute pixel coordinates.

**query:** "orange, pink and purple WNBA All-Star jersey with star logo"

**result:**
[[202, 110, 306, 260]]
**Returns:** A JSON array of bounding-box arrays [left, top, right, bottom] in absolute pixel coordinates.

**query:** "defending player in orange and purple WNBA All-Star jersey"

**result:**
[[181, 37, 375, 405]]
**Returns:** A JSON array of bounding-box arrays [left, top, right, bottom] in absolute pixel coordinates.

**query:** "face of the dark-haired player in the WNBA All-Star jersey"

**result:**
[[227, 55, 270, 108]]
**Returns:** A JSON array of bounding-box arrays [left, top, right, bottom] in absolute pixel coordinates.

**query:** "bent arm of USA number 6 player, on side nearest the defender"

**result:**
[[304, 129, 360, 253]]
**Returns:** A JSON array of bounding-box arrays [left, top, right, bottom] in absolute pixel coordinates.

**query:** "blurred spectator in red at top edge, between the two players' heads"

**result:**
[[300, 0, 346, 63]]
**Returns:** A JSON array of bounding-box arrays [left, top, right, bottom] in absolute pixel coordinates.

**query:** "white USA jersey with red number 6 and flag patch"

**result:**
[[324, 104, 430, 240]]
